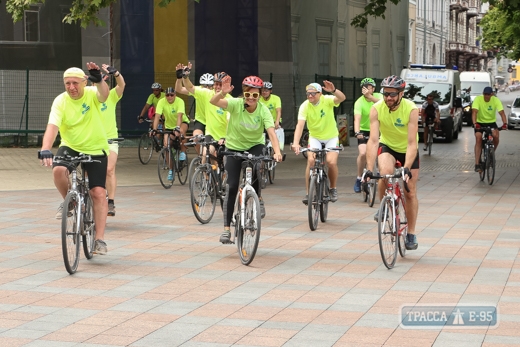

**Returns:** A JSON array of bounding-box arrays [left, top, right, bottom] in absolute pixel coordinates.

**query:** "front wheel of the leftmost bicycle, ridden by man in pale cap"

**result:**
[[61, 192, 80, 275]]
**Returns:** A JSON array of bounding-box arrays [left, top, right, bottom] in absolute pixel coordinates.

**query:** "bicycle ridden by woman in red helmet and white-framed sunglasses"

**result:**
[[222, 151, 282, 265]]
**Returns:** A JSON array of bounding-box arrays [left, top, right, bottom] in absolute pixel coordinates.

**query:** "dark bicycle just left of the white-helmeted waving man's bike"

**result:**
[[157, 130, 188, 189]]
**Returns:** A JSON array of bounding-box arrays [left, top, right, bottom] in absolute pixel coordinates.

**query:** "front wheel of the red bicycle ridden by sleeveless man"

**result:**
[[377, 196, 398, 269]]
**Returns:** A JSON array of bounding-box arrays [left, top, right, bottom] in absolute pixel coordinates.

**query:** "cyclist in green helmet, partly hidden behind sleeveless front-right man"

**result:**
[[354, 77, 383, 193]]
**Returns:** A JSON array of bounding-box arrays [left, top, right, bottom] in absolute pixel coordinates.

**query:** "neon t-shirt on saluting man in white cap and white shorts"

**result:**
[[298, 95, 339, 140]]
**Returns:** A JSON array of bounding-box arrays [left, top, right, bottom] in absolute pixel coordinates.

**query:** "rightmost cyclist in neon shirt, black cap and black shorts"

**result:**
[[471, 87, 507, 172]]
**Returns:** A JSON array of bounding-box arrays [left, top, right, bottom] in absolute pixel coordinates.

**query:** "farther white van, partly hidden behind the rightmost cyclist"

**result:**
[[460, 71, 493, 126]]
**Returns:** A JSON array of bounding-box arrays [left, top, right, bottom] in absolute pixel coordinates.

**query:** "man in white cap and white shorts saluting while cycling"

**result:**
[[292, 81, 346, 204]]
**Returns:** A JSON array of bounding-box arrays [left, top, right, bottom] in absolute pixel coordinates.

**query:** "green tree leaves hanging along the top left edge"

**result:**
[[0, 0, 200, 28]]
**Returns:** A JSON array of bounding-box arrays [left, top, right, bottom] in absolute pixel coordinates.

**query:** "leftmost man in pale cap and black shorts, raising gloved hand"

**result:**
[[40, 63, 109, 254]]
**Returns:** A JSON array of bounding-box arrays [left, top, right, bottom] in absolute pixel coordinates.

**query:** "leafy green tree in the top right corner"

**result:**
[[480, 0, 520, 60]]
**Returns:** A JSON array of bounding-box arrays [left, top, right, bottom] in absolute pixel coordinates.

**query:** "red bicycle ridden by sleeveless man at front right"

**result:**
[[363, 161, 410, 269]]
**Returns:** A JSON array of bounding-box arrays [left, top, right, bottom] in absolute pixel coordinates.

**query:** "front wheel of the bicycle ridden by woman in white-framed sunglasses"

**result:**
[[237, 189, 262, 265]]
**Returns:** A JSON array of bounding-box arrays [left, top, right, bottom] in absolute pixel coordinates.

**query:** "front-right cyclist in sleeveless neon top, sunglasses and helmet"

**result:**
[[365, 75, 419, 250]]
